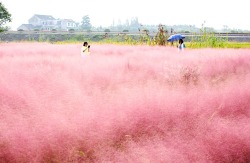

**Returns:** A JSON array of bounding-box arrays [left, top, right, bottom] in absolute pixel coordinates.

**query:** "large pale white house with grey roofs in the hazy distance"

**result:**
[[17, 14, 79, 31]]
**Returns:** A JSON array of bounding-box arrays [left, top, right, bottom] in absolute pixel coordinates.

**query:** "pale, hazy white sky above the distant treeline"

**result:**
[[0, 0, 250, 30]]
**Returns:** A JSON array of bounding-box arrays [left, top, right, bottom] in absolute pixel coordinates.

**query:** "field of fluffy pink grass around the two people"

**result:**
[[0, 43, 250, 163]]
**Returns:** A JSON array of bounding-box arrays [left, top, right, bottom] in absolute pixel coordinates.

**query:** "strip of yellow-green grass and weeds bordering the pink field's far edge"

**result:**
[[0, 33, 250, 49]]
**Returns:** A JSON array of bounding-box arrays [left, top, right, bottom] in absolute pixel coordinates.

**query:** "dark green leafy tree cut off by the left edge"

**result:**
[[0, 2, 11, 32]]
